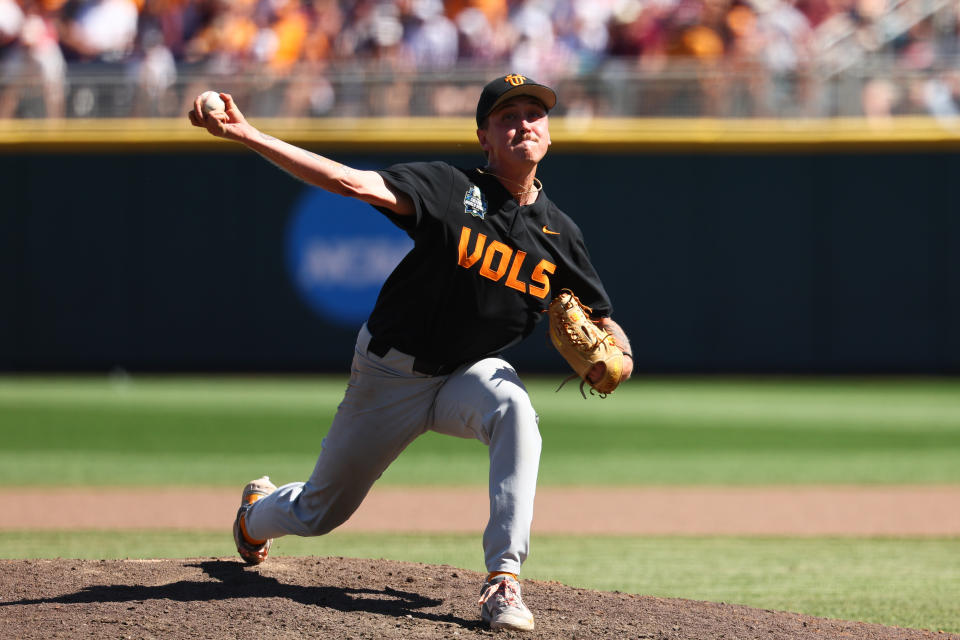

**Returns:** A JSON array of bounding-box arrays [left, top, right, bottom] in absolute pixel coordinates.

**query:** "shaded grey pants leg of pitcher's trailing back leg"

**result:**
[[246, 328, 445, 539]]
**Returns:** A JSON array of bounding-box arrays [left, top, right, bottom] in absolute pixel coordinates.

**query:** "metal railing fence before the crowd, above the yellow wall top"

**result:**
[[0, 56, 960, 118]]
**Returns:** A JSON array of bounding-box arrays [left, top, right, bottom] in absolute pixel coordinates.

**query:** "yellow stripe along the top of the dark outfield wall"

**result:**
[[0, 116, 960, 153]]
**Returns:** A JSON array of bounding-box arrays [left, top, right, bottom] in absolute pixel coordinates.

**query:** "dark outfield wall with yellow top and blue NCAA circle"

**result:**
[[0, 120, 960, 373]]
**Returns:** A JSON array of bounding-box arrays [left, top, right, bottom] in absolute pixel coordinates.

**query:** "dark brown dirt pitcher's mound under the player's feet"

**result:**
[[0, 557, 960, 640]]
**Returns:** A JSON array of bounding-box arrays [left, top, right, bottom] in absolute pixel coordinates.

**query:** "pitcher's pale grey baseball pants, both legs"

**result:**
[[246, 325, 541, 573]]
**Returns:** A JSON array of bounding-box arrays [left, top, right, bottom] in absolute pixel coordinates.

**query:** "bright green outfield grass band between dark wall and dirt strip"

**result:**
[[0, 377, 960, 486]]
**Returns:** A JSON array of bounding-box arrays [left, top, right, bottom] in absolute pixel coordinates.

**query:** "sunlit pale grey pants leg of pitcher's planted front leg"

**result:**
[[430, 358, 541, 573]]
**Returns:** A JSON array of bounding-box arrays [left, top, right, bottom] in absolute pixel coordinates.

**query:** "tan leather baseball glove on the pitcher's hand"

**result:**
[[547, 289, 623, 398]]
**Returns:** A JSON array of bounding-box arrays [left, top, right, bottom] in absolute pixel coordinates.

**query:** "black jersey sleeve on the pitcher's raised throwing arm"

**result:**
[[375, 162, 454, 232]]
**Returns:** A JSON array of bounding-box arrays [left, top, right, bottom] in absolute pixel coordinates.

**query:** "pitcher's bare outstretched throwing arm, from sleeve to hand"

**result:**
[[187, 93, 415, 215]]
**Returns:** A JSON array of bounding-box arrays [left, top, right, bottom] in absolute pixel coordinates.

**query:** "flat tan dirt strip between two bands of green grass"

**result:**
[[7, 486, 960, 536]]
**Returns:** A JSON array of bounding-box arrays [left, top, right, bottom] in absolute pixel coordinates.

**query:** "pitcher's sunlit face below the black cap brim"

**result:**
[[477, 96, 550, 166]]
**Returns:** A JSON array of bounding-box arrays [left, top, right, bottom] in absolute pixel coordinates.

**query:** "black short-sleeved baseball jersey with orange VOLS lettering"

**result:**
[[367, 162, 612, 365]]
